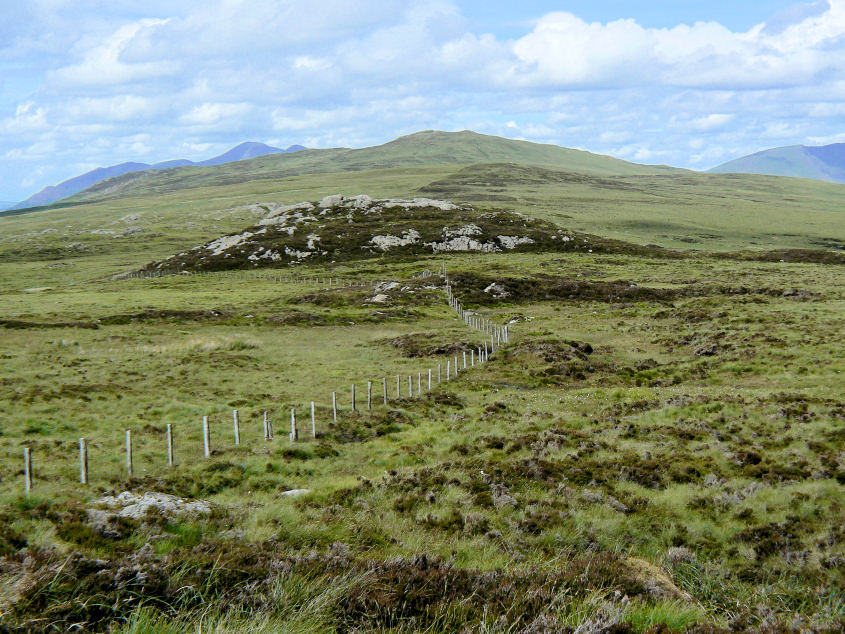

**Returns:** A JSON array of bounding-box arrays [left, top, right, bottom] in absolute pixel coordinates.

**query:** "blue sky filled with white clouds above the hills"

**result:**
[[0, 0, 845, 202]]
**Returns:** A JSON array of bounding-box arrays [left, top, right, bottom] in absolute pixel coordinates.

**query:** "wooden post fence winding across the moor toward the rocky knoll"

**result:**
[[19, 266, 510, 496]]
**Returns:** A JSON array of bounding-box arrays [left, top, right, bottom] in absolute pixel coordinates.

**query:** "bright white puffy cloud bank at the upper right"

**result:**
[[512, 0, 845, 89]]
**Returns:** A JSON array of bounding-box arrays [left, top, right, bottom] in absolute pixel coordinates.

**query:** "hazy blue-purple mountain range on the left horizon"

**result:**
[[7, 141, 305, 209]]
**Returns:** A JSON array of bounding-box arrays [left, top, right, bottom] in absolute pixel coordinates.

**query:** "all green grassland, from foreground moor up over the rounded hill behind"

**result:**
[[0, 135, 845, 632]]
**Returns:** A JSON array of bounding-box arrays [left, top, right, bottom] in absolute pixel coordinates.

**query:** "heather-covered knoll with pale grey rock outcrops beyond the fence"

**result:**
[[145, 195, 590, 271]]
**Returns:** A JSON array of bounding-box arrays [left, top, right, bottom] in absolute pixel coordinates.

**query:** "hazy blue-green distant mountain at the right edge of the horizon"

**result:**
[[710, 143, 845, 183]]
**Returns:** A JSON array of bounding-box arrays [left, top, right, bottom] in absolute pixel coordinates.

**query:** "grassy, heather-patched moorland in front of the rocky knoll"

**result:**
[[0, 246, 845, 631]]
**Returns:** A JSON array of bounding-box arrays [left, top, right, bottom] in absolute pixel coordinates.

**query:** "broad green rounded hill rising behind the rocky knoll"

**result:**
[[0, 132, 845, 286]]
